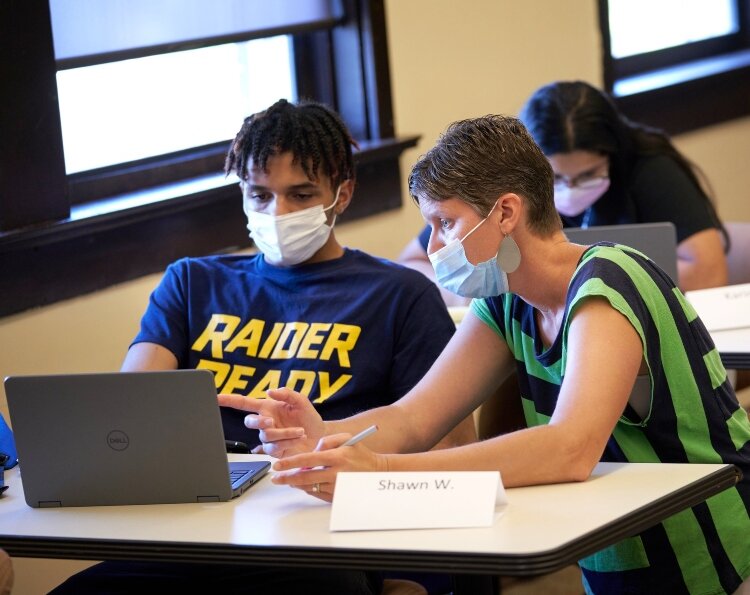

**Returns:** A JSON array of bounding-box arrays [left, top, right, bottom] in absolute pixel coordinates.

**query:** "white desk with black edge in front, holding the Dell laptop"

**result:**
[[0, 455, 738, 588]]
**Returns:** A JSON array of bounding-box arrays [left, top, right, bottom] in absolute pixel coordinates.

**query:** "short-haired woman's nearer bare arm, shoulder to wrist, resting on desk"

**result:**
[[387, 299, 643, 486]]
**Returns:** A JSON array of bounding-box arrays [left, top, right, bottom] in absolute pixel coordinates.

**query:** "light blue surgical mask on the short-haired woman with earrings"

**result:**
[[429, 207, 517, 298]]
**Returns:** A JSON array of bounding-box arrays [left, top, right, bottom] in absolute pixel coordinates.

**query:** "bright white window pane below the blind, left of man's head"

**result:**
[[57, 35, 296, 174]]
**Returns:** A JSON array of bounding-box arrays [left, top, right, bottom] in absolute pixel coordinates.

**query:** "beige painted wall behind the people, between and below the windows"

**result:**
[[5, 0, 750, 595]]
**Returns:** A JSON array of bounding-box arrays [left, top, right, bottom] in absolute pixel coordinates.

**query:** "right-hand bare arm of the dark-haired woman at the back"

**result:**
[[677, 229, 729, 291]]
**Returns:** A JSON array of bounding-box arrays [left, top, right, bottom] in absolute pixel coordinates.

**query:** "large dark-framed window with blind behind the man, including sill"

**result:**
[[0, 0, 418, 316]]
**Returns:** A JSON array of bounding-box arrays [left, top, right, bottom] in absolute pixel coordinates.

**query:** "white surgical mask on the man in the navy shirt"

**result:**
[[243, 186, 341, 266]]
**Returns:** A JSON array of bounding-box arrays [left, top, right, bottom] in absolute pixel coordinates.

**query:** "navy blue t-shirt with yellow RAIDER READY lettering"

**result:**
[[133, 249, 454, 445]]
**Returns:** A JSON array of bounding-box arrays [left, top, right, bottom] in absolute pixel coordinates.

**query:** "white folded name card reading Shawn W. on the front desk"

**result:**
[[330, 471, 508, 531]]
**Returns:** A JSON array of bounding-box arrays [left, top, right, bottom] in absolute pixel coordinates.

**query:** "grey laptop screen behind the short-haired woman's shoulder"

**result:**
[[563, 221, 677, 282]]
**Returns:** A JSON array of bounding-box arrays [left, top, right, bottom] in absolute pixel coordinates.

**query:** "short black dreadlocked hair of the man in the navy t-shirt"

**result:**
[[224, 99, 359, 188]]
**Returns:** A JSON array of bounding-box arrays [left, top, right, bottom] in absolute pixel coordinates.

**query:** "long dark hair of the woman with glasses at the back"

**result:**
[[521, 81, 729, 250]]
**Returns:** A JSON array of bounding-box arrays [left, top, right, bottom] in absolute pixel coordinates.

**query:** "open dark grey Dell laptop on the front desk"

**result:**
[[5, 370, 270, 508]]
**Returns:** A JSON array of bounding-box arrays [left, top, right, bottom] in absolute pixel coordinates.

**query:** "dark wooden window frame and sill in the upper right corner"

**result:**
[[599, 0, 750, 135]]
